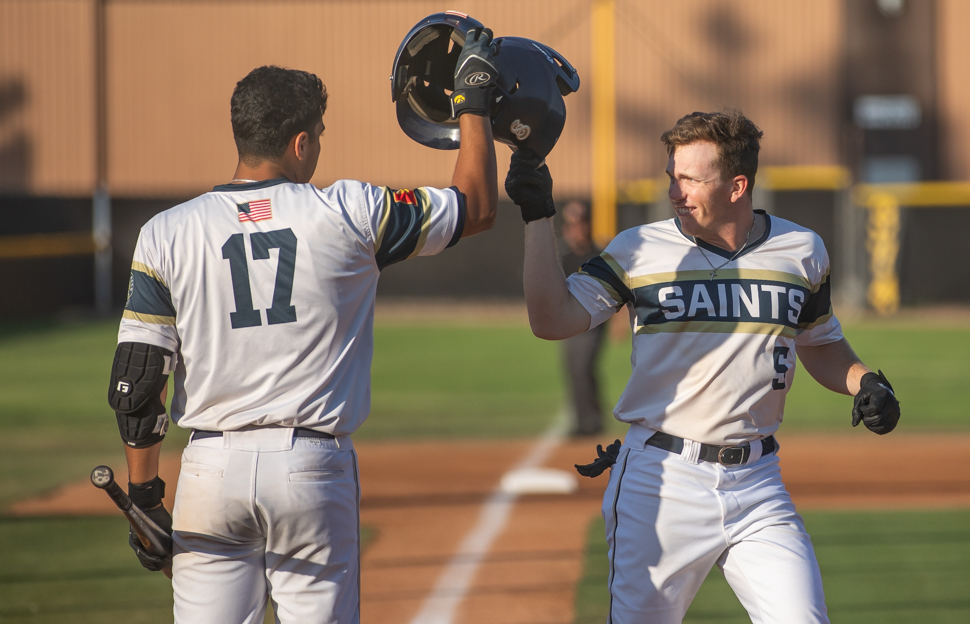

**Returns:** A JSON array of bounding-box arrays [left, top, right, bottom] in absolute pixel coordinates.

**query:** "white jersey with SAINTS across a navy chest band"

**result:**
[[568, 211, 842, 444]]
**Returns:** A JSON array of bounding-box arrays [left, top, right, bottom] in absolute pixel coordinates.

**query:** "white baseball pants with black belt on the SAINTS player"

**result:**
[[603, 425, 829, 624]]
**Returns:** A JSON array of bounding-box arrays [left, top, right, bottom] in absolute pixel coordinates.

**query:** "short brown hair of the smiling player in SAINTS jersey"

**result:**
[[660, 110, 764, 191]]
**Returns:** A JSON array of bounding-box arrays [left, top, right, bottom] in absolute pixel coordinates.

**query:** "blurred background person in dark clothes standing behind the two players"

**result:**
[[560, 201, 606, 436]]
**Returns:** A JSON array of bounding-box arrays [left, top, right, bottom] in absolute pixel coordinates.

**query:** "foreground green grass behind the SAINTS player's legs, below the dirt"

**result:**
[[575, 510, 970, 624]]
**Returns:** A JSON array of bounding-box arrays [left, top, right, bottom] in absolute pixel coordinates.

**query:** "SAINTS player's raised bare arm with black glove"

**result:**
[[505, 150, 591, 340]]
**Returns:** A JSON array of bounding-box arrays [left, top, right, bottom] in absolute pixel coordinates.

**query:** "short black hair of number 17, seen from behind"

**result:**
[[231, 65, 327, 165]]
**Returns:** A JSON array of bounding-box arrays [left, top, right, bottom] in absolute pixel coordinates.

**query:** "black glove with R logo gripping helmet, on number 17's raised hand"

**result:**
[[451, 28, 498, 119]]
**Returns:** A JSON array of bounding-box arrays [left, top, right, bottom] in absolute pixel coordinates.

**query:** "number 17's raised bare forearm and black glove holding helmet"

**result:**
[[451, 28, 498, 238]]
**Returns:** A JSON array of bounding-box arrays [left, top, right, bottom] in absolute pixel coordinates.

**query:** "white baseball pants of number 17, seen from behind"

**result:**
[[172, 428, 360, 624]]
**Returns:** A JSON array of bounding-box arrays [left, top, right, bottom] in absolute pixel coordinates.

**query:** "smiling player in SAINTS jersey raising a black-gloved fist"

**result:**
[[506, 112, 899, 624]]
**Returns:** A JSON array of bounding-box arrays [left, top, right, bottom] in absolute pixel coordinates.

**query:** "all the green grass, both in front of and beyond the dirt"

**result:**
[[0, 319, 970, 624]]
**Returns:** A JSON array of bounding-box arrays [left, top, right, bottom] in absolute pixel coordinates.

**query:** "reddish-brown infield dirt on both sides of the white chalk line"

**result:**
[[11, 431, 970, 624]]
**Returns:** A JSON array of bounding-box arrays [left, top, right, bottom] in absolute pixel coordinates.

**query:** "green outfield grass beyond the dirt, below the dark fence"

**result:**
[[0, 320, 970, 510]]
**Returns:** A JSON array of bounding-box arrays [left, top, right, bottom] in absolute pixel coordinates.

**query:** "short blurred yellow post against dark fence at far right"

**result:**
[[866, 193, 899, 314]]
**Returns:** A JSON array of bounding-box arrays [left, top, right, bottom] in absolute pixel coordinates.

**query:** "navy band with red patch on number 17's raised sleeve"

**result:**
[[374, 187, 431, 270]]
